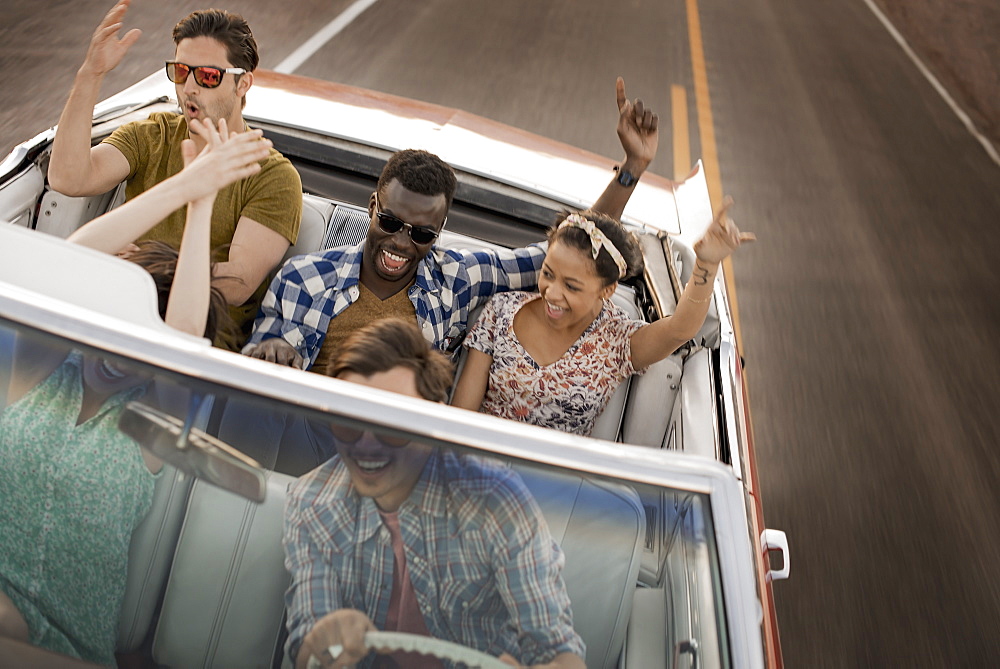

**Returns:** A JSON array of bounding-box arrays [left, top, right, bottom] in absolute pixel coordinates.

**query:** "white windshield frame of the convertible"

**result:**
[[0, 198, 763, 666]]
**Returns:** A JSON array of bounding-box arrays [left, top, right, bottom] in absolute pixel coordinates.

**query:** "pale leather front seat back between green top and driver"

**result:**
[[153, 472, 293, 669]]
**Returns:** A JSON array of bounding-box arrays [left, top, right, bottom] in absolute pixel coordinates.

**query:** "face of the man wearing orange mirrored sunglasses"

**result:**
[[174, 37, 253, 132]]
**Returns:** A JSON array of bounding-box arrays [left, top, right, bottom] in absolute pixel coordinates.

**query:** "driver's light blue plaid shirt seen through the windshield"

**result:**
[[283, 451, 585, 665]]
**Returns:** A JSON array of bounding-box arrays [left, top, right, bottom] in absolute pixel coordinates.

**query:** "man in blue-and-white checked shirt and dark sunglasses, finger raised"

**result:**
[[243, 78, 658, 373]]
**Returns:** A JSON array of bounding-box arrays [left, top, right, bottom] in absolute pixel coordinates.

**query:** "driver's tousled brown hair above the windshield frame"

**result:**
[[327, 318, 454, 402]]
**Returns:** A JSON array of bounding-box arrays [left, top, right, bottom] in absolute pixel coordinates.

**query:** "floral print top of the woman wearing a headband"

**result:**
[[465, 292, 645, 435]]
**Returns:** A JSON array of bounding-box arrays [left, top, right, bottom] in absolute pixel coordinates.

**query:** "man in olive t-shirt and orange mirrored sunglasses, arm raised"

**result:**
[[48, 5, 302, 348]]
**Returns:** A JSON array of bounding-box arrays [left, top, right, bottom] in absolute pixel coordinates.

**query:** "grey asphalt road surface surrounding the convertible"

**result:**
[[0, 0, 1000, 667]]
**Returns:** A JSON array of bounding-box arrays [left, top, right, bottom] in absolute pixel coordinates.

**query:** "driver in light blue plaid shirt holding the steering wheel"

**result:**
[[283, 319, 585, 669]]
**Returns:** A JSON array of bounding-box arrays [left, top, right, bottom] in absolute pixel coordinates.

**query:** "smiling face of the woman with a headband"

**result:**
[[538, 241, 615, 330]]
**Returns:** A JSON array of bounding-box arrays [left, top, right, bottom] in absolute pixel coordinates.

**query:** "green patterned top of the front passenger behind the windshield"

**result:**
[[0, 352, 155, 665]]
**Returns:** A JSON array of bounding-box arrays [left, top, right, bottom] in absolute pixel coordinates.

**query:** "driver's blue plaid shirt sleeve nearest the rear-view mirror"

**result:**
[[282, 472, 342, 665]]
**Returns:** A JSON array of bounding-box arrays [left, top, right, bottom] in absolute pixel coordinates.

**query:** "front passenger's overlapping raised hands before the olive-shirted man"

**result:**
[[178, 119, 271, 202]]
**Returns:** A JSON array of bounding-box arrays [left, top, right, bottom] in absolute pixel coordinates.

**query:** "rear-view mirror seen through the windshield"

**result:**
[[118, 402, 267, 503]]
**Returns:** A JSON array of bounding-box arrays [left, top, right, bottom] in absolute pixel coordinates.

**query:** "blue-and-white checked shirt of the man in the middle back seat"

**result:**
[[247, 242, 545, 368]]
